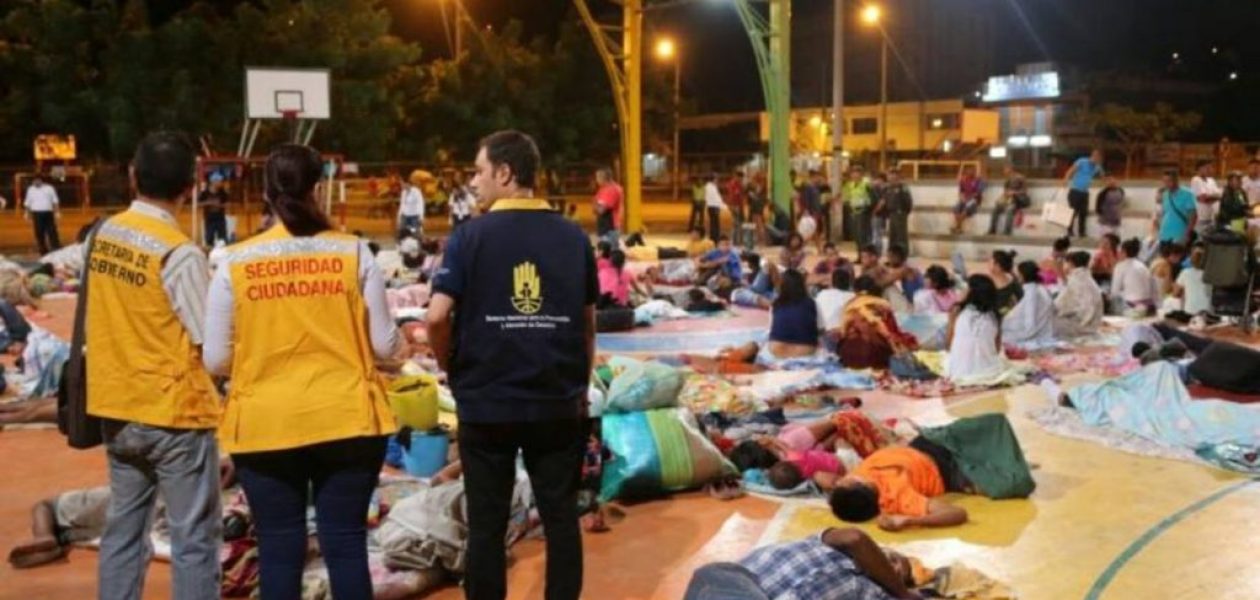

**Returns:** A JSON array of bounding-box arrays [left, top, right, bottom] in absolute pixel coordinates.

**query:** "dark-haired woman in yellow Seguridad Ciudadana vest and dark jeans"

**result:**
[[204, 145, 403, 600]]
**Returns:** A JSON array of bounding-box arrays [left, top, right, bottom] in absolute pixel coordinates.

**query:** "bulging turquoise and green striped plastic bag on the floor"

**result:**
[[600, 408, 737, 502]]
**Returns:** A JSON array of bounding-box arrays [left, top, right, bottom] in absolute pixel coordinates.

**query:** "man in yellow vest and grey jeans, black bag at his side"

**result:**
[[86, 132, 223, 600]]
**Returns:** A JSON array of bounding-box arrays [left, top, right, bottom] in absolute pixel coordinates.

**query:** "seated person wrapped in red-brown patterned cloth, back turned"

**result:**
[[828, 275, 919, 369]]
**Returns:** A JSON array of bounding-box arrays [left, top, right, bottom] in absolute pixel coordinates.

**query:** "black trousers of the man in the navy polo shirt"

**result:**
[[459, 418, 586, 600]]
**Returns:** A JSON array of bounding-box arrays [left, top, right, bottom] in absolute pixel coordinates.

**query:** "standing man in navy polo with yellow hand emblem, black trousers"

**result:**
[[427, 131, 599, 600]]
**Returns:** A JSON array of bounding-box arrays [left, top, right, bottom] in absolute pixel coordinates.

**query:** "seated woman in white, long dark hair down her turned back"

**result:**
[[945, 275, 1005, 381]]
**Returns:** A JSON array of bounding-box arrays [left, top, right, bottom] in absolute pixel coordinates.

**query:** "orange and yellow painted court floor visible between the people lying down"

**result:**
[[0, 255, 1260, 600]]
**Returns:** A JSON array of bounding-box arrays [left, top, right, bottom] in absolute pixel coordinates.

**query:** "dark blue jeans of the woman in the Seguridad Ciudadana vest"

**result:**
[[234, 437, 386, 600]]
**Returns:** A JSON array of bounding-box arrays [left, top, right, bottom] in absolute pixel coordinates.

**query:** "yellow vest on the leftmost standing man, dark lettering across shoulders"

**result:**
[[86, 211, 219, 429]]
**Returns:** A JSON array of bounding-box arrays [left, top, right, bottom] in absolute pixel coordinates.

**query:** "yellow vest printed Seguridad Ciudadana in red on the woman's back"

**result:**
[[219, 224, 396, 453]]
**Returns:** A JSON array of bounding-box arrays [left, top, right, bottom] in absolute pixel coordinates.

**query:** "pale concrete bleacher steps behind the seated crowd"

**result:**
[[910, 180, 1157, 261]]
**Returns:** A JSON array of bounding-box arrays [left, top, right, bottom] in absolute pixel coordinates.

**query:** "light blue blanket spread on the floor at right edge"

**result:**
[[1067, 362, 1260, 473]]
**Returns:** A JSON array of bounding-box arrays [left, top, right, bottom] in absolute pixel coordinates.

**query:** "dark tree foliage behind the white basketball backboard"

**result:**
[[0, 0, 655, 163]]
